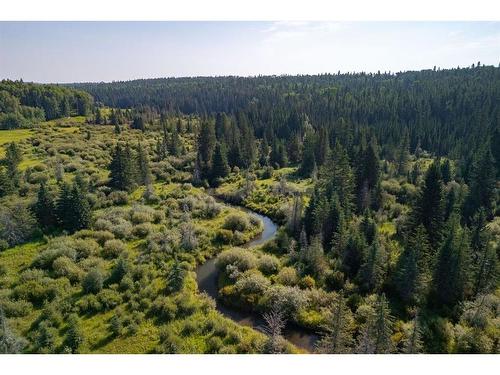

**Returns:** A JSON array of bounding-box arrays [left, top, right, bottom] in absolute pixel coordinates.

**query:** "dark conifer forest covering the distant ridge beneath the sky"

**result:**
[[72, 63, 500, 158]]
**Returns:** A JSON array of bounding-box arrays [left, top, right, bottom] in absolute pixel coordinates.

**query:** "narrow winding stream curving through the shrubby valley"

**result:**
[[196, 207, 318, 352]]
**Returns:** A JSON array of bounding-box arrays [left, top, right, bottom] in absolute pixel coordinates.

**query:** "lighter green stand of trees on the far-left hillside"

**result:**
[[0, 80, 93, 129]]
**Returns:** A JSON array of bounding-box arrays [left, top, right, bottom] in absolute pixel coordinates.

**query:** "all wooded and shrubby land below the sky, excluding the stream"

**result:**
[[0, 63, 500, 354]]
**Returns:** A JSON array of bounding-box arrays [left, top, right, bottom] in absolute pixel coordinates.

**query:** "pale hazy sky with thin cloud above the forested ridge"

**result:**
[[0, 22, 500, 82]]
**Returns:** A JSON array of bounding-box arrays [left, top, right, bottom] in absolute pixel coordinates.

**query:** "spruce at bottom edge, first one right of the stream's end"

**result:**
[[318, 294, 354, 354]]
